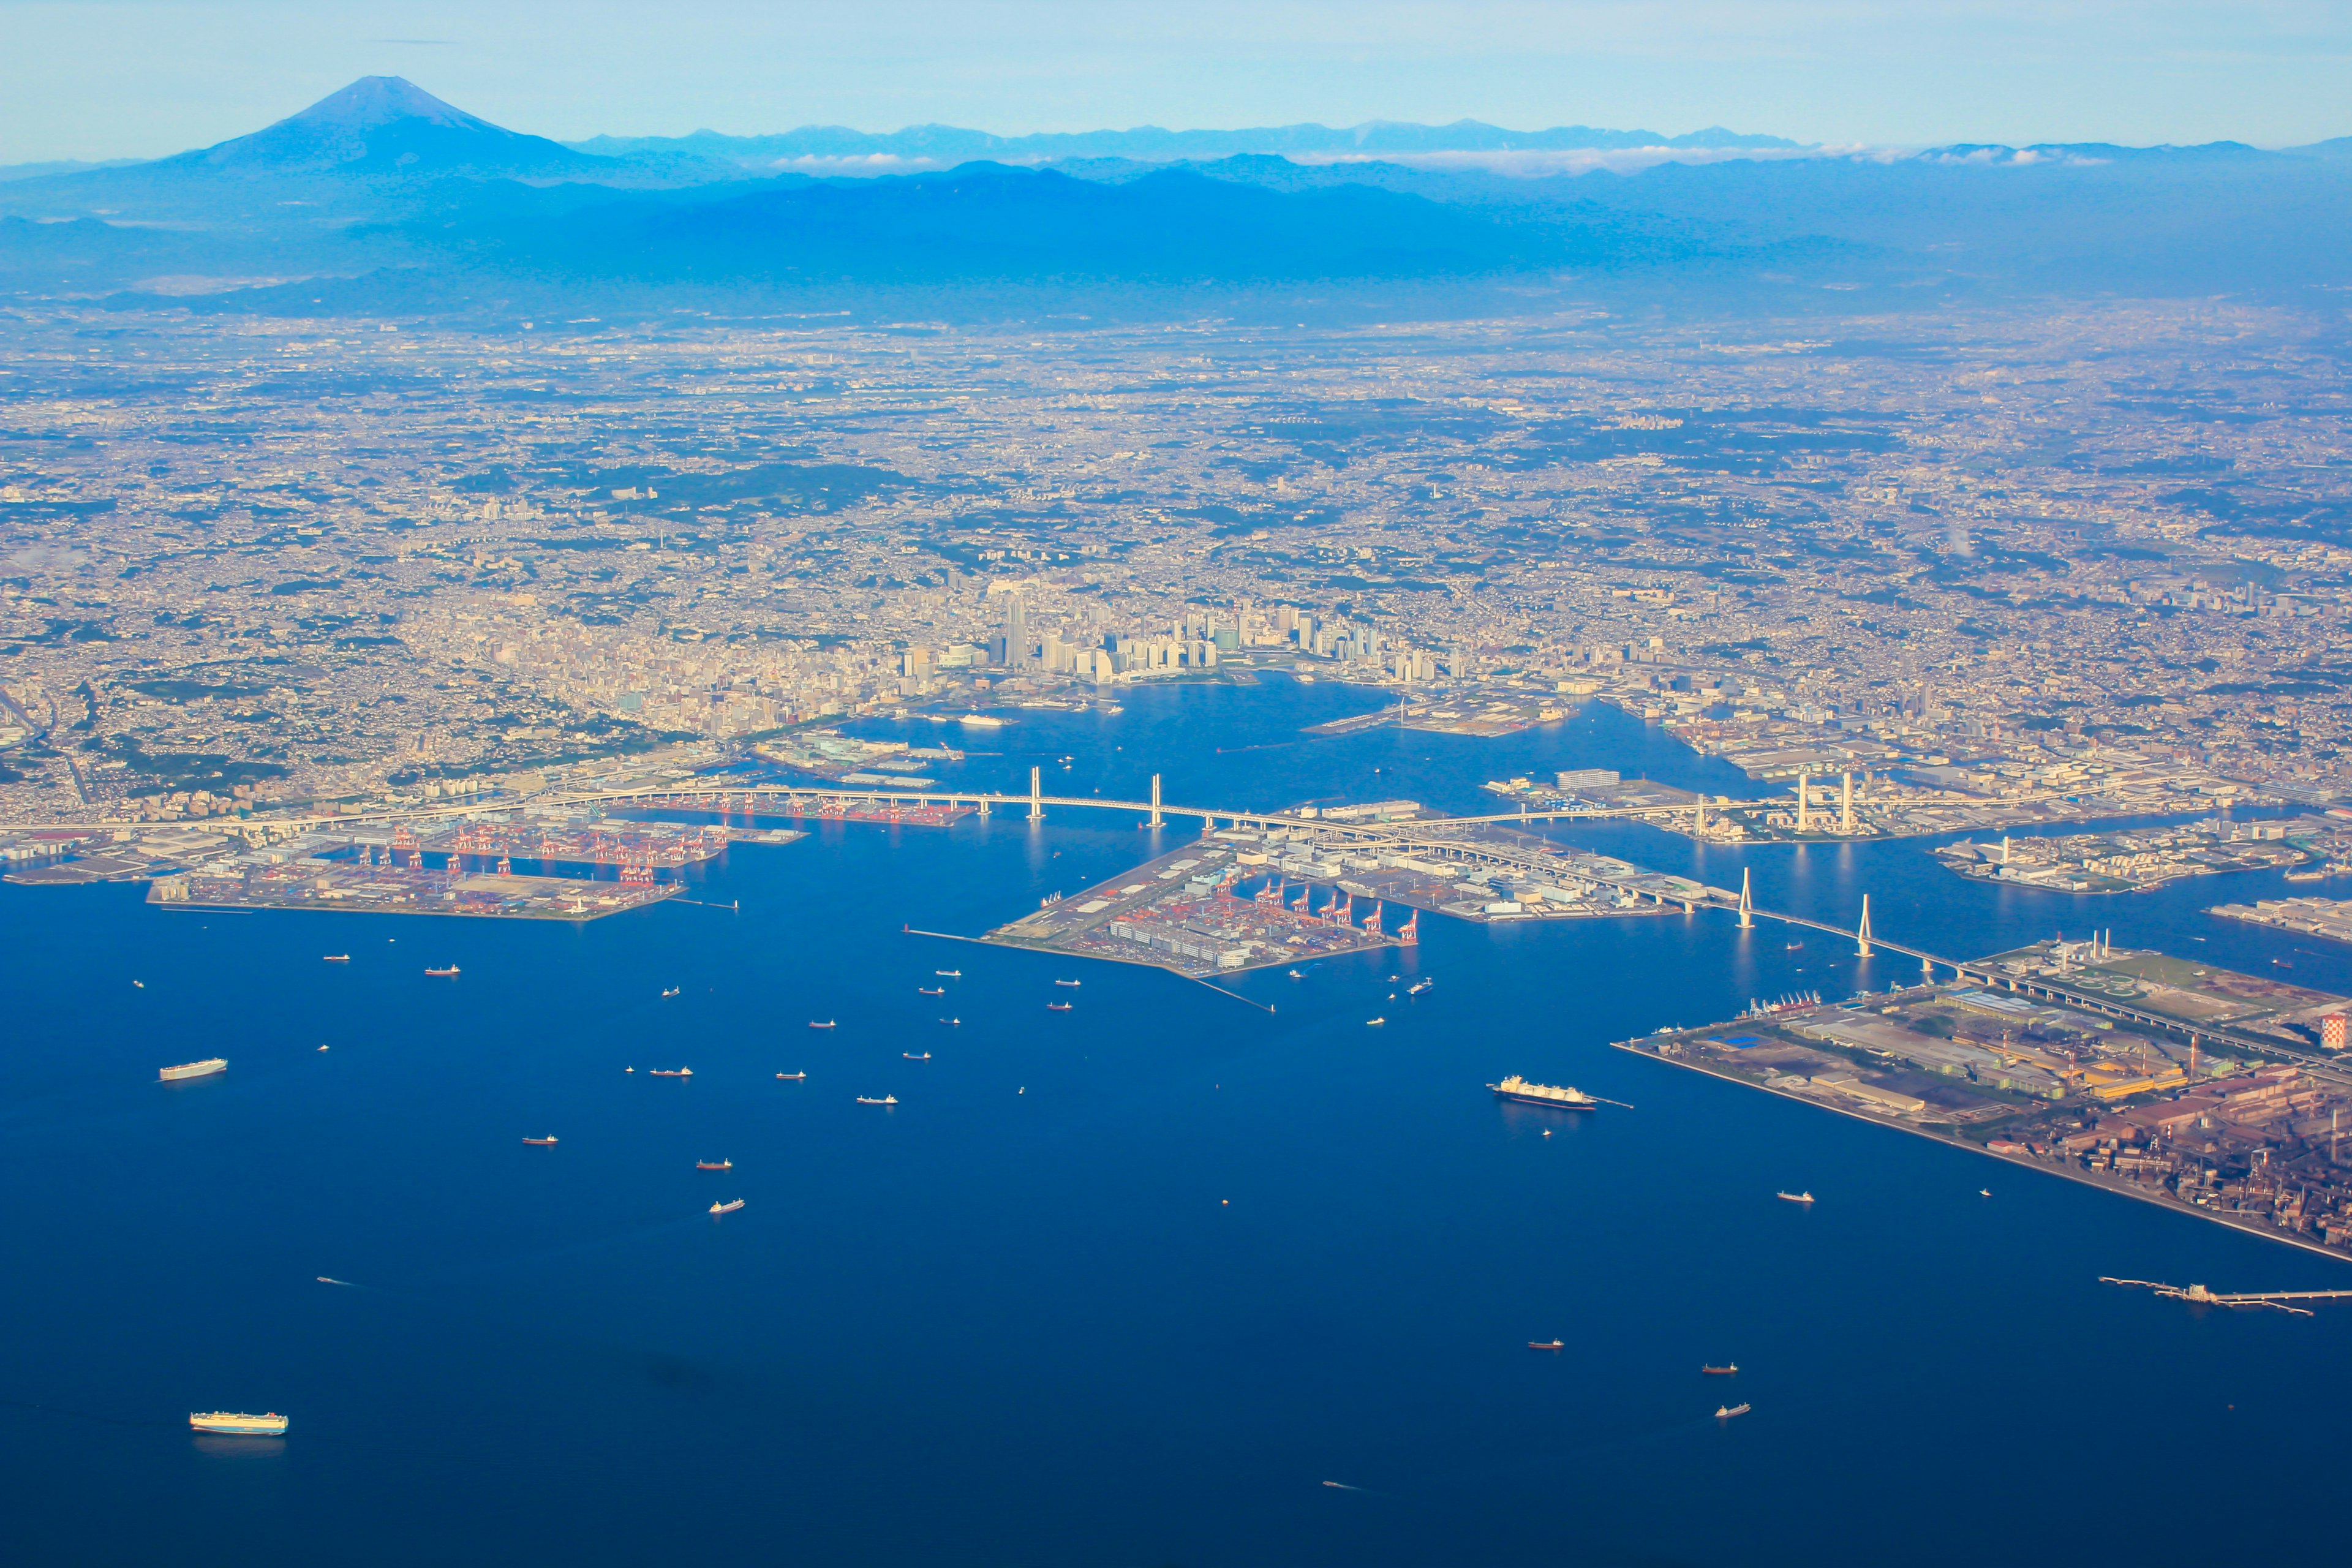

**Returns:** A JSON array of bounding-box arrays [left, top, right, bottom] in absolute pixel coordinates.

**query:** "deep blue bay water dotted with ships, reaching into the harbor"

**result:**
[[0, 679, 2352, 1568]]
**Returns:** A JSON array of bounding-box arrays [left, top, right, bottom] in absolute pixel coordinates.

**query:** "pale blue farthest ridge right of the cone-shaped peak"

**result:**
[[567, 120, 1801, 165]]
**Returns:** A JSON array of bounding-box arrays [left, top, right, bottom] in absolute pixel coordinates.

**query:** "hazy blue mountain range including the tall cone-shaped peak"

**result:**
[[0, 78, 2352, 311]]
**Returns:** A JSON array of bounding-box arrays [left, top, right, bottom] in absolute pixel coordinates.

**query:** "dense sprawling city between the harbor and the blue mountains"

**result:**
[[0, 303, 2352, 835]]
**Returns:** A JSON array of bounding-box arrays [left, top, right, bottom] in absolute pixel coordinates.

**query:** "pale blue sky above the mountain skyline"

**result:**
[[0, 0, 2352, 162]]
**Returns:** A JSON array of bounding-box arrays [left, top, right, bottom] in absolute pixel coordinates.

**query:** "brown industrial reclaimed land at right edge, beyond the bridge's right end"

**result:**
[[1613, 943, 2352, 1260]]
